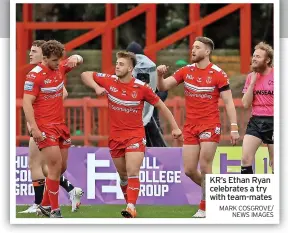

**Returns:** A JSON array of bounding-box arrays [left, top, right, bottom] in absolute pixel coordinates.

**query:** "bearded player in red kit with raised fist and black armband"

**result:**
[[157, 37, 239, 218]]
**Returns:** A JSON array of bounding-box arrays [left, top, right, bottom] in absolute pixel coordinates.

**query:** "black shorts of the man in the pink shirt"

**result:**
[[246, 116, 274, 144]]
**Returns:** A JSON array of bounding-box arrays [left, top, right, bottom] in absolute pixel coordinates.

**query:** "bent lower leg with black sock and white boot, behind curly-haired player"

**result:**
[[60, 148, 84, 212]]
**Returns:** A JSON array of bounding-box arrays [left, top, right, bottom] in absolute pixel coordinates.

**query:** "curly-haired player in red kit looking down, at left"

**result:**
[[23, 40, 82, 218]]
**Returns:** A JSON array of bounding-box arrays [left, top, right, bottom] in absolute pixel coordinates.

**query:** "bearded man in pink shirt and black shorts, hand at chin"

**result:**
[[241, 42, 274, 174]]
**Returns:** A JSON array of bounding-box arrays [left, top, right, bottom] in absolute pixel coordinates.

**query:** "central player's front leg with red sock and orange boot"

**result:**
[[121, 152, 144, 218]]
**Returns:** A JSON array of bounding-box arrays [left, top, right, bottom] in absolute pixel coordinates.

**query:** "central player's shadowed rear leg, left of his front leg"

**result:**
[[112, 156, 128, 203]]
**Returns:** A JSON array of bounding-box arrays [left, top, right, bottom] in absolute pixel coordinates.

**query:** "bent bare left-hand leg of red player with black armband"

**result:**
[[182, 145, 201, 186]]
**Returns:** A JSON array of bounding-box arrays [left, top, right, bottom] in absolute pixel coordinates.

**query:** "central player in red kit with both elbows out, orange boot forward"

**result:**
[[81, 52, 182, 218]]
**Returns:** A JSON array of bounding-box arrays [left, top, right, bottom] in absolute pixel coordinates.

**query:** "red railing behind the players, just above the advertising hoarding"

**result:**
[[16, 97, 250, 146]]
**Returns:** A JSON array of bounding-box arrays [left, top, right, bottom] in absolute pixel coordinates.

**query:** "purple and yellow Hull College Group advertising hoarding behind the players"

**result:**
[[16, 147, 267, 205]]
